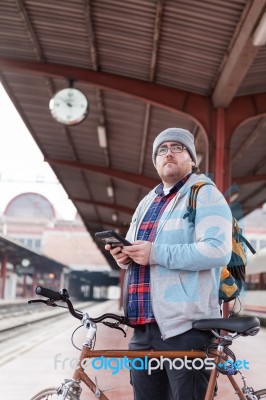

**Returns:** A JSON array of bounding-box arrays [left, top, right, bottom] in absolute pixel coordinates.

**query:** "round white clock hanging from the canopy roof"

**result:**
[[49, 88, 88, 125]]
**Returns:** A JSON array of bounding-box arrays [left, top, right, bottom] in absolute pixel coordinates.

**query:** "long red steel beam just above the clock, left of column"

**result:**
[[0, 58, 211, 132]]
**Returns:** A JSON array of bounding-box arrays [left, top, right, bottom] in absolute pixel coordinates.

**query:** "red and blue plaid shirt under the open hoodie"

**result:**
[[128, 174, 191, 325]]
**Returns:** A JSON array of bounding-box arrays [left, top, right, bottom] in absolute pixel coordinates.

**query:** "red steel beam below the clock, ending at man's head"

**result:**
[[44, 158, 160, 189]]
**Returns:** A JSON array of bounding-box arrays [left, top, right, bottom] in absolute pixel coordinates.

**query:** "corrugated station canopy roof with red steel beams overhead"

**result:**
[[0, 0, 266, 266]]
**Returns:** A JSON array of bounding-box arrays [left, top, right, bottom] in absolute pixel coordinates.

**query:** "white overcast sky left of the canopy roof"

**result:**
[[0, 83, 76, 219]]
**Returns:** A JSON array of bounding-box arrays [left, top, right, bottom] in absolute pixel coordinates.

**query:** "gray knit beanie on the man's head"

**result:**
[[152, 128, 197, 165]]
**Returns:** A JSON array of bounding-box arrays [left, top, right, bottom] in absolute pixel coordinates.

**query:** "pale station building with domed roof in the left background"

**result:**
[[0, 192, 119, 299]]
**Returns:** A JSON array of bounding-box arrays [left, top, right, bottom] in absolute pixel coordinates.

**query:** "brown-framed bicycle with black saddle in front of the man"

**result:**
[[28, 286, 266, 400]]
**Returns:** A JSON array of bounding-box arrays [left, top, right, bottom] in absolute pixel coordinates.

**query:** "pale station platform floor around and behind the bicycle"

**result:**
[[0, 300, 266, 400]]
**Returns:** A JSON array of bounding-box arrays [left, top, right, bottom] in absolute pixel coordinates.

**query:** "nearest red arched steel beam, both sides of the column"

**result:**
[[0, 58, 266, 142]]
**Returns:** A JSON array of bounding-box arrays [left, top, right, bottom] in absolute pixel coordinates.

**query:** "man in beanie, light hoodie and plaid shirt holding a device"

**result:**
[[106, 128, 232, 400]]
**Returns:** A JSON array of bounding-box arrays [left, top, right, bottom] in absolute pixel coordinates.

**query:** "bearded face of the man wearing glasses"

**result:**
[[155, 142, 195, 187]]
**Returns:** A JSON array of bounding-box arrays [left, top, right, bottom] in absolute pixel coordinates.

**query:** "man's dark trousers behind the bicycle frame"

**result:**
[[129, 324, 212, 400]]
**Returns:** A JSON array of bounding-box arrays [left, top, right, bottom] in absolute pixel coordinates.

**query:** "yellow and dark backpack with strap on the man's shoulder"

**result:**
[[183, 182, 256, 302]]
